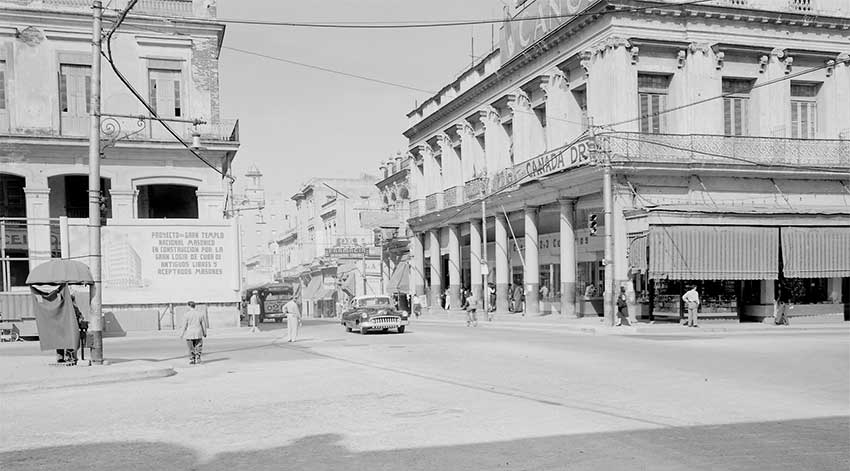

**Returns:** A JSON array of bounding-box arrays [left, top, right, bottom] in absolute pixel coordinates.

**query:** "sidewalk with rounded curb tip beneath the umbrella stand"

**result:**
[[0, 350, 176, 394]]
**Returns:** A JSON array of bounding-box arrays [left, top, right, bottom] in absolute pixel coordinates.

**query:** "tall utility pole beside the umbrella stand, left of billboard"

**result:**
[[89, 0, 103, 365]]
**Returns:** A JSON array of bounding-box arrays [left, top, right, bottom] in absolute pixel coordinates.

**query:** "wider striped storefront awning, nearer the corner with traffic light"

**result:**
[[649, 225, 779, 280]]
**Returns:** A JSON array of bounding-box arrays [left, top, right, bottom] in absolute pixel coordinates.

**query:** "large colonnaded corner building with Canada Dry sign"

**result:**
[[404, 0, 850, 320]]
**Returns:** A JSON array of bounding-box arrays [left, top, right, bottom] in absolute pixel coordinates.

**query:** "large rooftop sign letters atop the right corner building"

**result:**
[[501, 0, 596, 64]]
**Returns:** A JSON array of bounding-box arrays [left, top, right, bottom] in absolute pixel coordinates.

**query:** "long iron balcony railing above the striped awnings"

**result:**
[[605, 133, 850, 168]]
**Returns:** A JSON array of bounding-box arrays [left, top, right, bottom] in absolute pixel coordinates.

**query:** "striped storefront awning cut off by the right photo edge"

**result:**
[[780, 226, 850, 278]]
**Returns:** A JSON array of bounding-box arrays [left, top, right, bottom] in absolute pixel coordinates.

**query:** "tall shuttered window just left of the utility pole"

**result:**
[[59, 64, 91, 136]]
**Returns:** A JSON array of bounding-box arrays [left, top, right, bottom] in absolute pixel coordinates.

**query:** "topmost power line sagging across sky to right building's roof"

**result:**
[[107, 0, 710, 29]]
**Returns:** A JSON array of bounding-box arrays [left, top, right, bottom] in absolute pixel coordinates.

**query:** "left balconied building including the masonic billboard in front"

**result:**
[[0, 0, 239, 330]]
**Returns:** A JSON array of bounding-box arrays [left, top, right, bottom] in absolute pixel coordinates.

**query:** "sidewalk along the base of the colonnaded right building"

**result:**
[[412, 310, 850, 335]]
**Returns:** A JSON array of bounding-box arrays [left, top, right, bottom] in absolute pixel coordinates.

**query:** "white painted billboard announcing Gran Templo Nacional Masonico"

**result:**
[[66, 221, 239, 305]]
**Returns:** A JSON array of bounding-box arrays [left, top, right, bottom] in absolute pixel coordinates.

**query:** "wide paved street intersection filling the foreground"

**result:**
[[0, 321, 850, 471]]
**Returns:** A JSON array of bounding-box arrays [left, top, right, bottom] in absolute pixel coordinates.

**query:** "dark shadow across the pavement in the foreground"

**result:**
[[0, 417, 850, 471]]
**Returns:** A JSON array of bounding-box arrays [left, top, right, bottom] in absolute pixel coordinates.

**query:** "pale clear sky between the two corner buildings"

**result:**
[[218, 0, 504, 198]]
